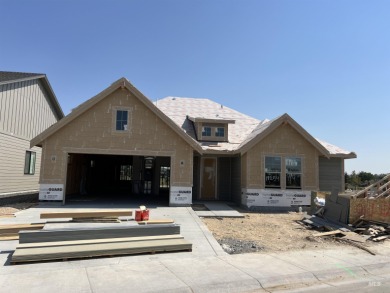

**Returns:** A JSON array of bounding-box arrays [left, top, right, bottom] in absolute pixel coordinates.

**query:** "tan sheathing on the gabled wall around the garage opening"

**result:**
[[32, 81, 194, 186]]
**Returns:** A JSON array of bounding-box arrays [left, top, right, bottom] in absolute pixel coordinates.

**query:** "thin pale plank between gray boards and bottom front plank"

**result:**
[[16, 234, 184, 249]]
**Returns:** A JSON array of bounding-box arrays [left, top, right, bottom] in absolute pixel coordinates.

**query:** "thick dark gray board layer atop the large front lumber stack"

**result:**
[[19, 224, 180, 243]]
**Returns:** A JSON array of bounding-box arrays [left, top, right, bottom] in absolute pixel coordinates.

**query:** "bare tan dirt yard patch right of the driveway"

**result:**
[[202, 210, 345, 254]]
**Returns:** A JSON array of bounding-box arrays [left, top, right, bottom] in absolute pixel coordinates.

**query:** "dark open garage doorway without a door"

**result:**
[[66, 154, 171, 204]]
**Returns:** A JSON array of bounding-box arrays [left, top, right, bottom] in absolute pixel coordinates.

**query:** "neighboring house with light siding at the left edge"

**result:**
[[0, 71, 64, 198]]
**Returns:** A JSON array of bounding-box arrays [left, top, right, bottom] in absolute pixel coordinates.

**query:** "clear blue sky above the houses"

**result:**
[[0, 0, 390, 174]]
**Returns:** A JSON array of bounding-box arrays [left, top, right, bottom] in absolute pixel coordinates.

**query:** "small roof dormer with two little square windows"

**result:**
[[187, 116, 235, 142]]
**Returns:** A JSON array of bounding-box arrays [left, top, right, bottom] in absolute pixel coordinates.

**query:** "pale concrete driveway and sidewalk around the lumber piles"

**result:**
[[0, 205, 390, 293]]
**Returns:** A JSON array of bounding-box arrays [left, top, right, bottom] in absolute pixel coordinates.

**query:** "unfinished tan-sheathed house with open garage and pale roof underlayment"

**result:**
[[31, 78, 356, 208]]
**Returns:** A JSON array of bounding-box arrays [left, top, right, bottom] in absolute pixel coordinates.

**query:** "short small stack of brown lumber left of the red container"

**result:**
[[41, 210, 133, 223]]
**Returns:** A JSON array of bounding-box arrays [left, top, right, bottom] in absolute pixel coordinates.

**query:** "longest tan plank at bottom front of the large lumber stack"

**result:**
[[11, 239, 192, 264]]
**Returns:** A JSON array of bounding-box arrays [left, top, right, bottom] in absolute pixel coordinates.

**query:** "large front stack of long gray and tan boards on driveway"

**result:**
[[11, 224, 192, 264]]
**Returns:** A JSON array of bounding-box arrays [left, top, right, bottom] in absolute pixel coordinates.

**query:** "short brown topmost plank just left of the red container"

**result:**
[[41, 210, 133, 219]]
